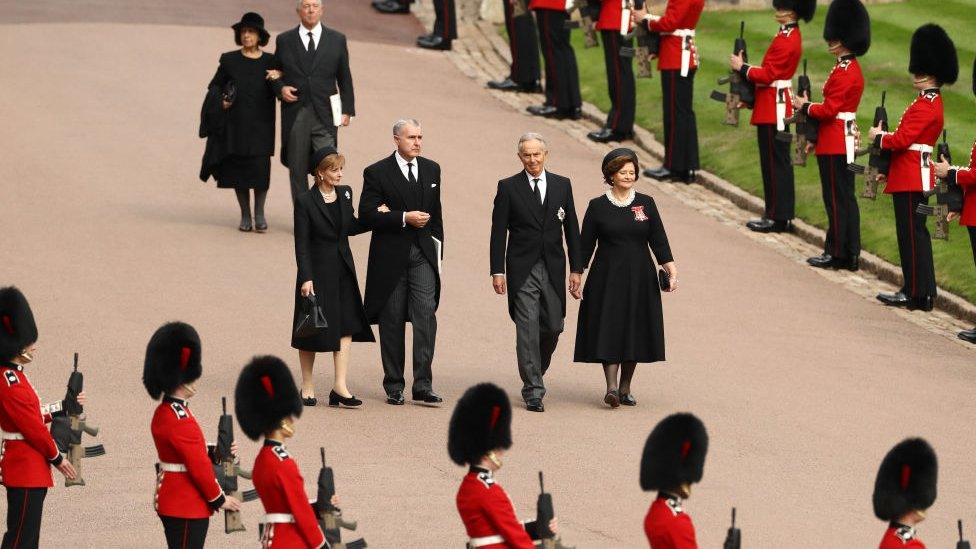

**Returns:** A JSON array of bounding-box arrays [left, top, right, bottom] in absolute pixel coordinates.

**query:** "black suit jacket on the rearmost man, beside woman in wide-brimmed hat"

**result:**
[[272, 25, 356, 164]]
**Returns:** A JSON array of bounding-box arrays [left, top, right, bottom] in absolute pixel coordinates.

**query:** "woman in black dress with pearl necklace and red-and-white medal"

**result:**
[[574, 149, 678, 408]]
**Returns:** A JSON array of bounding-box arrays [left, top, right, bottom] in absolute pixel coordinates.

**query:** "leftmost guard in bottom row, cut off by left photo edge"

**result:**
[[0, 286, 83, 549]]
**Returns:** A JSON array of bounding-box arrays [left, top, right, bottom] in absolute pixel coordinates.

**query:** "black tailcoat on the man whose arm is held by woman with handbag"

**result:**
[[359, 154, 444, 324]]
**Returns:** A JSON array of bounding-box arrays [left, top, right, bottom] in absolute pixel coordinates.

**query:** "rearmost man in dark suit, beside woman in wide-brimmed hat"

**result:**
[[271, 0, 356, 203]]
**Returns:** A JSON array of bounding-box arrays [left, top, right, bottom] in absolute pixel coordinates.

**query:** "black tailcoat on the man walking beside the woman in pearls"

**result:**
[[490, 171, 585, 319]]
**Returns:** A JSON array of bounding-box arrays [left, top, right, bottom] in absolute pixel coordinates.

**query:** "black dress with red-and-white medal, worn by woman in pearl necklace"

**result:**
[[574, 193, 672, 363]]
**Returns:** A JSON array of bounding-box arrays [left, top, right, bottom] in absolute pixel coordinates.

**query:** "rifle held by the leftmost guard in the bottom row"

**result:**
[[51, 353, 105, 486]]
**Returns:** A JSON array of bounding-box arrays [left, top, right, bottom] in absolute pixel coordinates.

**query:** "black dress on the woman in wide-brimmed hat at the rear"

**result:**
[[210, 50, 278, 190]]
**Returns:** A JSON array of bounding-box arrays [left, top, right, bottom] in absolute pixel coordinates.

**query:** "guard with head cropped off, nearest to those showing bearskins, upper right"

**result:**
[[634, 0, 705, 183]]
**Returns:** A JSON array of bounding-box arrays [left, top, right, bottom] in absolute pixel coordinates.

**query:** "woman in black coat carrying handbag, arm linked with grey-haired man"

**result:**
[[291, 147, 382, 406]]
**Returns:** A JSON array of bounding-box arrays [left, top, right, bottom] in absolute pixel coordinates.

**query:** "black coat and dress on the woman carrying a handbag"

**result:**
[[291, 185, 376, 352]]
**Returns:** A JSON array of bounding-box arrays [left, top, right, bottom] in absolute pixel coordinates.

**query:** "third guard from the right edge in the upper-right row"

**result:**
[[794, 0, 871, 271]]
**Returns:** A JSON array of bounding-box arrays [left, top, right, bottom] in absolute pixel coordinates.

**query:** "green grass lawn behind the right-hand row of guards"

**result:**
[[540, 0, 976, 302]]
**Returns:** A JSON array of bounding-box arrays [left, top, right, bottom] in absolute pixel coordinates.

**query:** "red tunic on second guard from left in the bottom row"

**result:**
[[152, 396, 224, 519]]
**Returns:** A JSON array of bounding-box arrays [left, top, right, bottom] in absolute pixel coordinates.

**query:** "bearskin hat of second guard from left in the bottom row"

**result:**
[[142, 322, 203, 400]]
